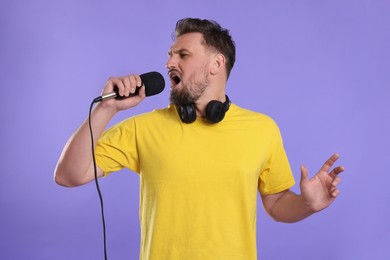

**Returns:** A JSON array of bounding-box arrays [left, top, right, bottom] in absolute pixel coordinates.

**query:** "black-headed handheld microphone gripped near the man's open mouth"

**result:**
[[93, 71, 165, 103]]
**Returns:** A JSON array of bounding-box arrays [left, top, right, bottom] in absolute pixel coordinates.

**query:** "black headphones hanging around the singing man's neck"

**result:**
[[176, 95, 230, 124]]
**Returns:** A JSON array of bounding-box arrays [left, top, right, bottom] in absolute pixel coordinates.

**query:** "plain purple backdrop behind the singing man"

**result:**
[[0, 0, 390, 260]]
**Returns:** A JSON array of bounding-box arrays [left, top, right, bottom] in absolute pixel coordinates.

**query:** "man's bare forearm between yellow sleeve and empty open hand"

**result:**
[[268, 191, 315, 223]]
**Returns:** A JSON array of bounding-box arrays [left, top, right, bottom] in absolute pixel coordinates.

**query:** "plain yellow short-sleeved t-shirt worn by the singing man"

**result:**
[[96, 104, 295, 260]]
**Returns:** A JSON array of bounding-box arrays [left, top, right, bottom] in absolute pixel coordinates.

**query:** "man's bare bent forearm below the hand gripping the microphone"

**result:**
[[54, 104, 115, 187]]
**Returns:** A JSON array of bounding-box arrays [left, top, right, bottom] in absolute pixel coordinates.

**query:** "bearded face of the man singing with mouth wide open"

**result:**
[[166, 33, 210, 105]]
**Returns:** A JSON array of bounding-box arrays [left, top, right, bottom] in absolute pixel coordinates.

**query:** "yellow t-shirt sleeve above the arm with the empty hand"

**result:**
[[258, 123, 295, 195]]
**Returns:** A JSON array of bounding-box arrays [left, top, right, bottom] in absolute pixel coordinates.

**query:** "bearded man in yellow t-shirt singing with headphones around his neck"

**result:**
[[55, 18, 344, 260]]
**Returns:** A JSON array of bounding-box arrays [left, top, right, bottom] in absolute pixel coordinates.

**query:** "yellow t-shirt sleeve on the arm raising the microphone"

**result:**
[[95, 118, 139, 176]]
